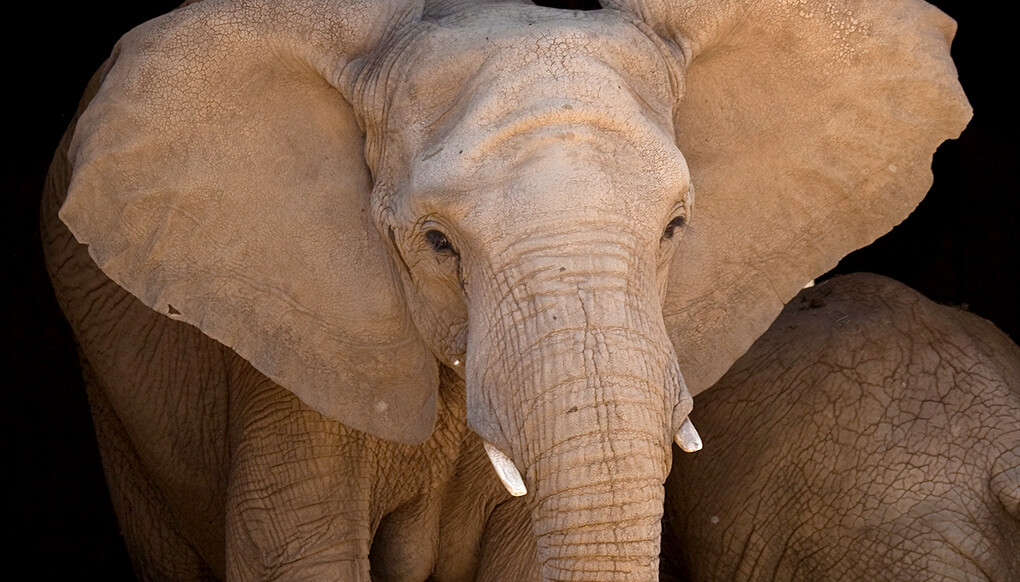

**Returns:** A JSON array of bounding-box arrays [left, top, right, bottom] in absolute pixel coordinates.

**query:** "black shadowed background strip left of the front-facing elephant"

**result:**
[[0, 0, 176, 581]]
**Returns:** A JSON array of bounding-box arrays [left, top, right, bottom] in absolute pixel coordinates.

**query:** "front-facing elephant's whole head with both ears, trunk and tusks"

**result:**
[[60, 0, 970, 579]]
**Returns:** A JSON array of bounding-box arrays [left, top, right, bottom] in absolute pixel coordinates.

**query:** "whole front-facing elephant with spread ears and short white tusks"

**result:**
[[43, 0, 970, 580]]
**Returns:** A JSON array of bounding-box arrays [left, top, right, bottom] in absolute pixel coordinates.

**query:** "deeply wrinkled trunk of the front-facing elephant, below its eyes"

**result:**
[[468, 235, 691, 581]]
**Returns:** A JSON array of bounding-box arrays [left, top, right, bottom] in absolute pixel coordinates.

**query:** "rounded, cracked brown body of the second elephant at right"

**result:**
[[663, 274, 1020, 582]]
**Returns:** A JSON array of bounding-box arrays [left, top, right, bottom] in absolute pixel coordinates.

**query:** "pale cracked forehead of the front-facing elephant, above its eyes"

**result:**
[[385, 5, 680, 188]]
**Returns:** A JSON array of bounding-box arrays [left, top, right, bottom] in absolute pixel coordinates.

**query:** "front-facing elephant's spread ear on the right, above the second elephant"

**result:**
[[610, 0, 970, 393]]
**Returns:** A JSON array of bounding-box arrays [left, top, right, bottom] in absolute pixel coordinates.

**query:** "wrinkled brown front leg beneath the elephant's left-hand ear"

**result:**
[[226, 363, 377, 582]]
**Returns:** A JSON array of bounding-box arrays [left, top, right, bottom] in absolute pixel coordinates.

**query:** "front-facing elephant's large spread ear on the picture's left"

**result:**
[[60, 0, 439, 443]]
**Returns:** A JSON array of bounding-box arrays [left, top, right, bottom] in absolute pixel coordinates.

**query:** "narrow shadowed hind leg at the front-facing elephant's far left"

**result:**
[[83, 362, 216, 581]]
